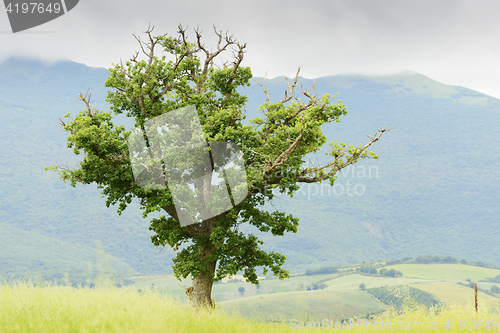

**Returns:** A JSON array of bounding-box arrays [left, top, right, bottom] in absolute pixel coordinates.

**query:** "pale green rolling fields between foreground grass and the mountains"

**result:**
[[120, 264, 500, 321]]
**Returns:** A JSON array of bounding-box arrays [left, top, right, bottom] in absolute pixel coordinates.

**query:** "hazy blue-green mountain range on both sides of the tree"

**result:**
[[0, 59, 500, 278]]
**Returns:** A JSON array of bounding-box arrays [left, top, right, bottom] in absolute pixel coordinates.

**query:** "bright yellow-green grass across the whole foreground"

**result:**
[[0, 284, 500, 333]]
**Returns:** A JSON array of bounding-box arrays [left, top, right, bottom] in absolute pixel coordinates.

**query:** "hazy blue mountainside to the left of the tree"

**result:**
[[0, 59, 172, 278]]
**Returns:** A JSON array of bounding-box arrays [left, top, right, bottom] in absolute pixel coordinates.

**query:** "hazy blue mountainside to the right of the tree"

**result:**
[[240, 72, 500, 268]]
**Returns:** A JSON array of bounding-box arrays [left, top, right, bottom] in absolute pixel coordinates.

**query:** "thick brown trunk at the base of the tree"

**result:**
[[186, 247, 217, 307]]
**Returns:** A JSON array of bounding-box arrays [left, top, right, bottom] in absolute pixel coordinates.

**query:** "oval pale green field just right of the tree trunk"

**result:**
[[219, 289, 385, 321]]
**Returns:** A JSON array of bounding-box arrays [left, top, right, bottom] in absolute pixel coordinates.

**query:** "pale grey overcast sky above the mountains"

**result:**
[[0, 0, 500, 98]]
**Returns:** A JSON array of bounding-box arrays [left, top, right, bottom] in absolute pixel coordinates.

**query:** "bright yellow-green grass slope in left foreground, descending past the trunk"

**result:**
[[0, 284, 287, 333]]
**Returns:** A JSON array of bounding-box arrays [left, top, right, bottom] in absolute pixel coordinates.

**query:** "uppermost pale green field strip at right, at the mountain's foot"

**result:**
[[387, 264, 500, 281]]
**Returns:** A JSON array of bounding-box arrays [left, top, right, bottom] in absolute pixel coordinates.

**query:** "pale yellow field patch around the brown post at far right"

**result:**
[[413, 282, 500, 308]]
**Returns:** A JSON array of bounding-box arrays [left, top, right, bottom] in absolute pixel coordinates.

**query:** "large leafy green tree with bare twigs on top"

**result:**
[[48, 26, 386, 306]]
